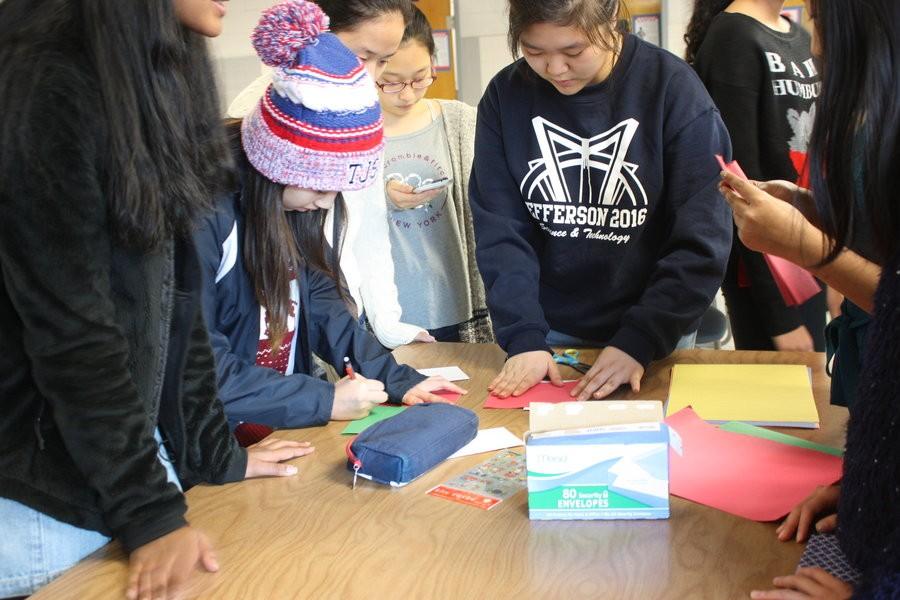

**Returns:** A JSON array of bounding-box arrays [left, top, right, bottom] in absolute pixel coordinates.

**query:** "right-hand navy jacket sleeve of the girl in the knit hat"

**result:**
[[304, 268, 425, 401]]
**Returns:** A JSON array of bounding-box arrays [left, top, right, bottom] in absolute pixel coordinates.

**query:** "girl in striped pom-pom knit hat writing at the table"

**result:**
[[195, 0, 464, 441]]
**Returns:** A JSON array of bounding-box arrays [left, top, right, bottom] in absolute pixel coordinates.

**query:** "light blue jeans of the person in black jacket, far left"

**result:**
[[0, 429, 181, 598]]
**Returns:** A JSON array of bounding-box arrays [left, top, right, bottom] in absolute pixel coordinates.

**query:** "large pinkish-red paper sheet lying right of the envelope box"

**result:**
[[666, 407, 843, 521]]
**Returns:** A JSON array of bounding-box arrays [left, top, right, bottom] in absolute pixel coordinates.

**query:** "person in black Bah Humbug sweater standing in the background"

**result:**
[[685, 0, 825, 352]]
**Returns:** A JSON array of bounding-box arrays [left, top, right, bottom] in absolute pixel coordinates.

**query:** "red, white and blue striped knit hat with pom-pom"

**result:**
[[241, 0, 384, 191]]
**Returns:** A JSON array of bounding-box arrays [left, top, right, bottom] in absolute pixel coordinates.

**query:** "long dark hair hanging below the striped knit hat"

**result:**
[[226, 119, 350, 348]]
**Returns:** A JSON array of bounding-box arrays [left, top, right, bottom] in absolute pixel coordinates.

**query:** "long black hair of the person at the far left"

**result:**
[[0, 0, 230, 249]]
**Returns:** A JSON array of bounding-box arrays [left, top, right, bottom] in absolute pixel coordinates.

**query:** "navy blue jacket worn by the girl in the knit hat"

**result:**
[[194, 192, 425, 428]]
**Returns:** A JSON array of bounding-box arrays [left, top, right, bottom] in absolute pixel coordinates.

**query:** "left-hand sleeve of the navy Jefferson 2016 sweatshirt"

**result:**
[[469, 85, 550, 356]]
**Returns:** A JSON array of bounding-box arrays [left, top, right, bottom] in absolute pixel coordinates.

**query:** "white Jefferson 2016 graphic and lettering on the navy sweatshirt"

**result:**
[[519, 117, 647, 244]]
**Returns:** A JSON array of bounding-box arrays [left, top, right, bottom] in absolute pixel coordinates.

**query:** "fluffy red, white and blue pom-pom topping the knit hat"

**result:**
[[251, 0, 328, 68]]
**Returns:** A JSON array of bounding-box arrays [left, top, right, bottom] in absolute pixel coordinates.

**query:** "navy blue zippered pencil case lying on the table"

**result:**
[[347, 404, 478, 487]]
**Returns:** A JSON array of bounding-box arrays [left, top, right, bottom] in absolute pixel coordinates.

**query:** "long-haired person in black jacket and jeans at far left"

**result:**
[[0, 0, 311, 598]]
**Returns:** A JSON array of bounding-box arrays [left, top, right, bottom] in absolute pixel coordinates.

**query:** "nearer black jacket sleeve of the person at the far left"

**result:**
[[0, 67, 185, 550]]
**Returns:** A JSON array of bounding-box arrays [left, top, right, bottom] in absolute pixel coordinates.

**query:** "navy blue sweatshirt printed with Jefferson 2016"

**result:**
[[469, 35, 732, 365]]
